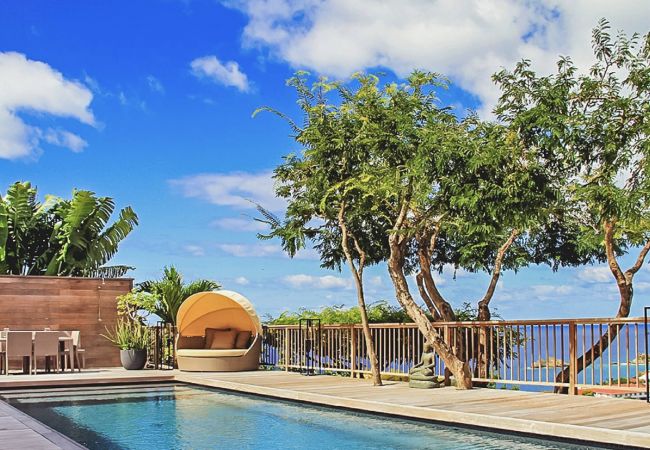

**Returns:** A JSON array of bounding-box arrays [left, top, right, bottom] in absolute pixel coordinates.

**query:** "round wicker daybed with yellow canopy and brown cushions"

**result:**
[[176, 291, 262, 372]]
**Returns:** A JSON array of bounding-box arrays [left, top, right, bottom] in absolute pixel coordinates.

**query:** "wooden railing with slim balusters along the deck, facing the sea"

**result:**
[[262, 318, 650, 393]]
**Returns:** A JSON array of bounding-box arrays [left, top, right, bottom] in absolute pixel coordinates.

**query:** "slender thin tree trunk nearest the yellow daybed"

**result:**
[[339, 204, 382, 386]]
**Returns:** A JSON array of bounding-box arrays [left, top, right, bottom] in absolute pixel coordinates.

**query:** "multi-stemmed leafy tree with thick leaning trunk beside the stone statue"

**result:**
[[316, 71, 571, 388]]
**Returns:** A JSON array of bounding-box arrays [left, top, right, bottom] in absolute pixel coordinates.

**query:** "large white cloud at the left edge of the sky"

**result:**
[[0, 52, 95, 159]]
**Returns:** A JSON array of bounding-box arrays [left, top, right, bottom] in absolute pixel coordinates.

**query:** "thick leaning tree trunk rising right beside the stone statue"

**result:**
[[388, 233, 472, 389]]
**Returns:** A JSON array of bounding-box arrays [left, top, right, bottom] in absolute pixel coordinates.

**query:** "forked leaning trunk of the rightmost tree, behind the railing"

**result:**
[[554, 220, 650, 394]]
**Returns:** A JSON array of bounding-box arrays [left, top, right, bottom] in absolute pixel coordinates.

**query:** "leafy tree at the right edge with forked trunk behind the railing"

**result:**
[[494, 19, 650, 390]]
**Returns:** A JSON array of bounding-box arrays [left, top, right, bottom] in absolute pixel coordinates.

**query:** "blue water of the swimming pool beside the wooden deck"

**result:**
[[3, 384, 592, 450]]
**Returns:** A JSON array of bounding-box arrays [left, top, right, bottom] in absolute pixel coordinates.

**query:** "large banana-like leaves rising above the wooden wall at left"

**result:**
[[0, 182, 138, 276]]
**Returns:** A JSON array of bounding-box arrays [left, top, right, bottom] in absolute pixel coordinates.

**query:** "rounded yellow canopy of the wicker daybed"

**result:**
[[176, 290, 262, 336]]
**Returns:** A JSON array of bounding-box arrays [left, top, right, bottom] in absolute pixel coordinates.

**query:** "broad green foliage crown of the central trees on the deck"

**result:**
[[259, 67, 573, 324]]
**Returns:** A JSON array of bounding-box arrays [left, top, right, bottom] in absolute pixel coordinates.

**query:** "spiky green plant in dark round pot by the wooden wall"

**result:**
[[103, 318, 150, 370]]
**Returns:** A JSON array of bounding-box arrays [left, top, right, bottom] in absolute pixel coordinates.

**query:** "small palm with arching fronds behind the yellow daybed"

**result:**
[[136, 266, 221, 325]]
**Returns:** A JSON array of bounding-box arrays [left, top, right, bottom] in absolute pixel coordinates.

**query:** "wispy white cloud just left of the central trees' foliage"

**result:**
[[170, 171, 285, 211]]
